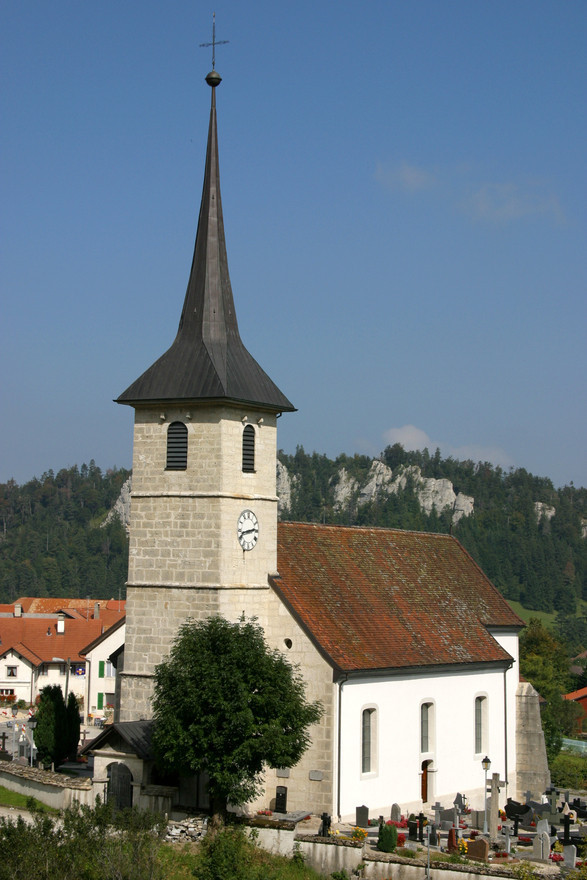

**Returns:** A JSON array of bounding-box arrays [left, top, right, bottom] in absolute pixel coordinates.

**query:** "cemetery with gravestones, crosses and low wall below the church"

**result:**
[[216, 773, 587, 880]]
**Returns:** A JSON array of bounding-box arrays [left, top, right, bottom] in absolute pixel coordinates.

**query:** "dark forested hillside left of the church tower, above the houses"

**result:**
[[0, 460, 129, 602]]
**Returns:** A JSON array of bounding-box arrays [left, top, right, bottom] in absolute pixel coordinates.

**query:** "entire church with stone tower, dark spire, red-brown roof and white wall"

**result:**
[[86, 70, 548, 818]]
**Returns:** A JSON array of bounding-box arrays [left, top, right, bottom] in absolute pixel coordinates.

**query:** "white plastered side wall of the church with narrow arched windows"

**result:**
[[340, 669, 509, 819]]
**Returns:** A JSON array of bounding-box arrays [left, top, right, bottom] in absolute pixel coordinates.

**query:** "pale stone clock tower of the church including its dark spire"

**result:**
[[117, 70, 294, 721]]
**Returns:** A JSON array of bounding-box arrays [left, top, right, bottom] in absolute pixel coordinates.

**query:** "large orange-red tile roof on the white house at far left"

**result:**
[[0, 617, 119, 666]]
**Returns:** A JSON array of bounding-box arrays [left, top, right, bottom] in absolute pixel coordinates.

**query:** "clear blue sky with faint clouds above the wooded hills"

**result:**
[[0, 0, 587, 486]]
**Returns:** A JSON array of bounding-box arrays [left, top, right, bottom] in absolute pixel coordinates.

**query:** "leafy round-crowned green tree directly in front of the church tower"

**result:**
[[153, 617, 322, 814]]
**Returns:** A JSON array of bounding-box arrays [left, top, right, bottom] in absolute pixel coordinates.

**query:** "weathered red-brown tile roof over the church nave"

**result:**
[[271, 523, 524, 672]]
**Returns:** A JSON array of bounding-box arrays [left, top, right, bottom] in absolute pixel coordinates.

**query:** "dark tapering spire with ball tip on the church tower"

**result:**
[[116, 70, 295, 412]]
